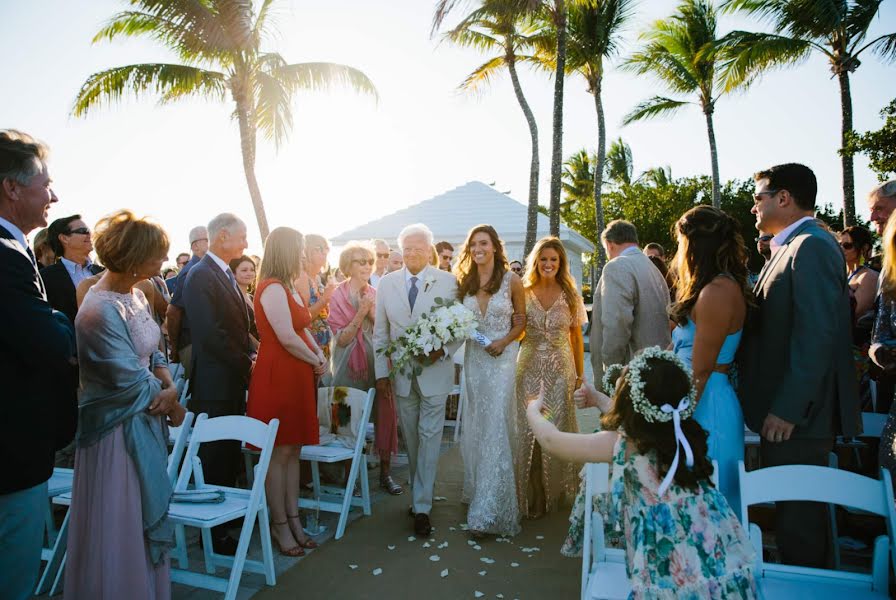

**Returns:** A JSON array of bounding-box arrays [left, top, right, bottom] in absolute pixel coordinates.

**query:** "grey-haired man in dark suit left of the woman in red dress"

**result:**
[[183, 213, 252, 554]]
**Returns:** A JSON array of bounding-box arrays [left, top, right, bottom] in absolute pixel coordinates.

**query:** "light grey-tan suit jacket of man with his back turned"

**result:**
[[590, 252, 672, 386]]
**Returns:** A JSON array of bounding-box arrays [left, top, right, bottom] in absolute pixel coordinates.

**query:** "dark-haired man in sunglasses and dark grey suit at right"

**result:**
[[738, 164, 861, 567]]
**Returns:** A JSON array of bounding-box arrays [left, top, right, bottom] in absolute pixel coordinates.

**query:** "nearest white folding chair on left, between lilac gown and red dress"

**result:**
[[168, 413, 280, 600]]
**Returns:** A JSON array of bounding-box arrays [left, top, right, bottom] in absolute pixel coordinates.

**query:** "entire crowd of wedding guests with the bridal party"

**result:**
[[7, 120, 896, 599]]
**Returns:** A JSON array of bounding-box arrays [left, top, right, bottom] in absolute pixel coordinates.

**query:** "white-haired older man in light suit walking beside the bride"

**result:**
[[373, 224, 461, 535]]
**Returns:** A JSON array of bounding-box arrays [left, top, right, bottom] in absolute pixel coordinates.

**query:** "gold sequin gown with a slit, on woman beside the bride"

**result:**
[[514, 290, 588, 515]]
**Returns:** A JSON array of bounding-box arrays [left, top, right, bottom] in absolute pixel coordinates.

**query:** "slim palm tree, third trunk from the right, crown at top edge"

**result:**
[[566, 0, 634, 273]]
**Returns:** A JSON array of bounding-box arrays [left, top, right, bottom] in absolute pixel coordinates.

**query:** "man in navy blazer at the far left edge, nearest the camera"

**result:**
[[0, 130, 77, 600]]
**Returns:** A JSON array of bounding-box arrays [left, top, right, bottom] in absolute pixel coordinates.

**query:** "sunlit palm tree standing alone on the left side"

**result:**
[[72, 0, 377, 239]]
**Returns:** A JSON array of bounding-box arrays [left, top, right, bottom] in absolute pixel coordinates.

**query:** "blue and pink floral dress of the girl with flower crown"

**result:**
[[598, 431, 757, 600]]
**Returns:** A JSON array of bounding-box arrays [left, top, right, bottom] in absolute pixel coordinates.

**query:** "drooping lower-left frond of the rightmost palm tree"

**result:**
[[719, 31, 812, 92]]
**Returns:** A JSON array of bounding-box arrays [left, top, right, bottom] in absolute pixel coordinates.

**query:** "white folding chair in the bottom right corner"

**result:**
[[739, 461, 896, 600]]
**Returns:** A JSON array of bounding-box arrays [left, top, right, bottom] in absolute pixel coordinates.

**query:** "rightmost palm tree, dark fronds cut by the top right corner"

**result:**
[[723, 0, 896, 227]]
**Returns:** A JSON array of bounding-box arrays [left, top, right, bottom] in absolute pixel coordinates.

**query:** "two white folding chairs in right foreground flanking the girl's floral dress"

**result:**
[[581, 461, 896, 600]]
